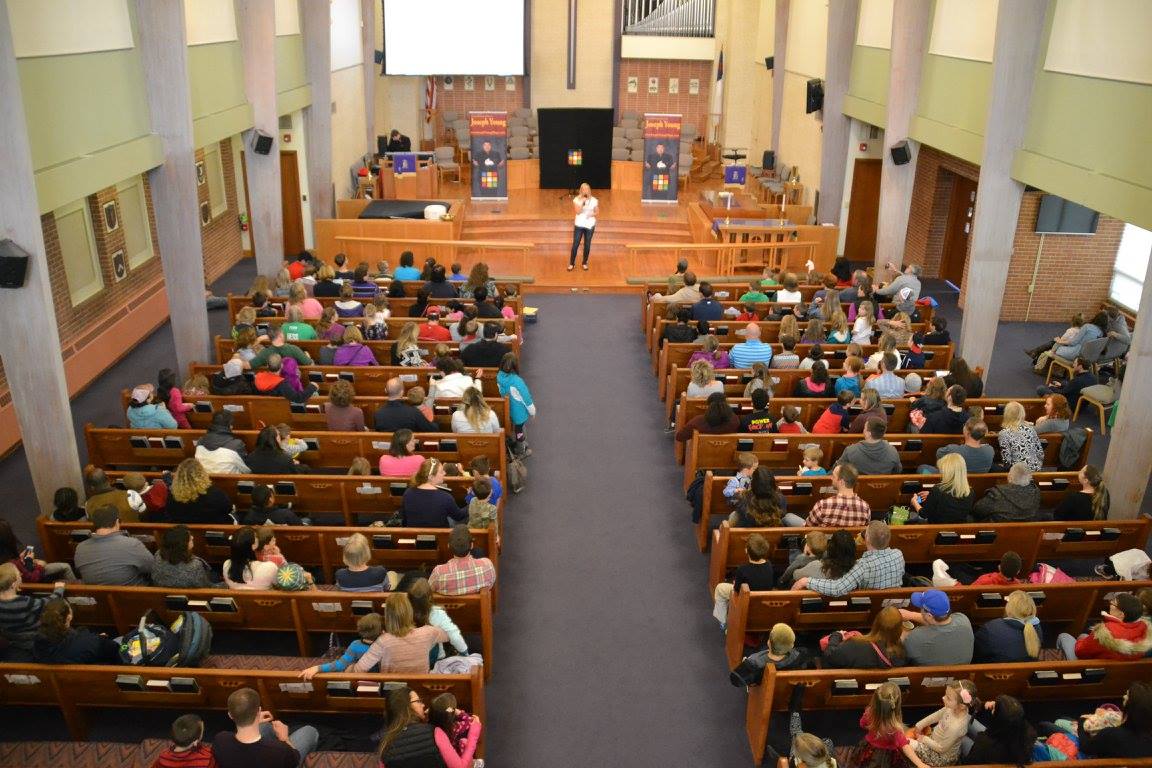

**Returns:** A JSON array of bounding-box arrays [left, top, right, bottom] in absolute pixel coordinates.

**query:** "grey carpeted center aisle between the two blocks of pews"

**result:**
[[485, 294, 750, 766]]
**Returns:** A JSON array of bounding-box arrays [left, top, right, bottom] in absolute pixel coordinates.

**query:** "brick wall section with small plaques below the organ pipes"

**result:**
[[616, 59, 712, 132]]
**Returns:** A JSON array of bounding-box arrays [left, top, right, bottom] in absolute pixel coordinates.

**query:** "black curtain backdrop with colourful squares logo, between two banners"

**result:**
[[536, 109, 613, 189]]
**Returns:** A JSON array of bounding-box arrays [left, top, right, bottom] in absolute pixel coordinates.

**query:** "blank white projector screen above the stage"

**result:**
[[384, 0, 524, 75]]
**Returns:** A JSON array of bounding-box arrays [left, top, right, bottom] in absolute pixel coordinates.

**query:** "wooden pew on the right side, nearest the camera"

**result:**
[[744, 660, 1152, 766]]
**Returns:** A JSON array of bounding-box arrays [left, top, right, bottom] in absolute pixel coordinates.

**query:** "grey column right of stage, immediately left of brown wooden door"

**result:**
[[816, 0, 859, 225]]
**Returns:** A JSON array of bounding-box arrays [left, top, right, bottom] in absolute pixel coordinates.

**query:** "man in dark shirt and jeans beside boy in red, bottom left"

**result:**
[[212, 687, 320, 768]]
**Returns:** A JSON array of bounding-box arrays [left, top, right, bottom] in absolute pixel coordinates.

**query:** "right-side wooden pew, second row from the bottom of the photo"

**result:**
[[725, 581, 1152, 669]]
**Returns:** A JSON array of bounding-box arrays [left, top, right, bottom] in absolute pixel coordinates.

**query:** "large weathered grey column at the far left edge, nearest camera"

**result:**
[[0, 2, 84, 510]]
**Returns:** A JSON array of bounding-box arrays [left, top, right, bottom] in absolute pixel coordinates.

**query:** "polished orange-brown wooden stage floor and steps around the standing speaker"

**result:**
[[440, 180, 722, 292]]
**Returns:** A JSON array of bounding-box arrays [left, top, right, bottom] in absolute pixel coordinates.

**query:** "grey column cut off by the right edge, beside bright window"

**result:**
[[1101, 249, 1152, 519]]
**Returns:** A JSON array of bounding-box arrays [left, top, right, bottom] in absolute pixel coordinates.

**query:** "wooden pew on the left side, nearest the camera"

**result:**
[[0, 663, 486, 754]]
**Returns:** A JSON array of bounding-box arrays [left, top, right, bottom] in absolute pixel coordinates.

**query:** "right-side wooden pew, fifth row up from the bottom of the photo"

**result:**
[[684, 429, 1092, 491]]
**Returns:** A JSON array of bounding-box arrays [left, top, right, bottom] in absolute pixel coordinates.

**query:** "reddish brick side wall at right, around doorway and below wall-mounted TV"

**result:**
[[904, 146, 1124, 322]]
